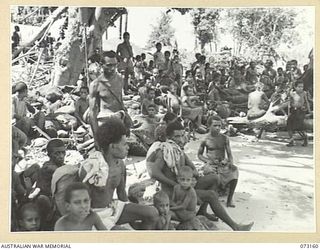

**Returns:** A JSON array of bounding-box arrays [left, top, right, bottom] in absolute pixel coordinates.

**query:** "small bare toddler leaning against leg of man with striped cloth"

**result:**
[[170, 166, 197, 222]]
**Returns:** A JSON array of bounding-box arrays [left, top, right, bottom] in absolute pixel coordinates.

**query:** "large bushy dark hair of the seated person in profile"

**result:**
[[97, 117, 127, 149]]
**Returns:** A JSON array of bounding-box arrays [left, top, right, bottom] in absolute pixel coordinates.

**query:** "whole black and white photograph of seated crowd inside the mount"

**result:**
[[10, 5, 317, 233]]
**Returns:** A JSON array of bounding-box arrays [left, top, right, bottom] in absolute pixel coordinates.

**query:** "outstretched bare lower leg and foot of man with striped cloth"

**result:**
[[196, 190, 253, 231]]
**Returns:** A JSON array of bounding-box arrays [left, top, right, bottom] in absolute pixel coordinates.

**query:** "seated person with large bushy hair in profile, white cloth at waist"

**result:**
[[80, 117, 159, 230]]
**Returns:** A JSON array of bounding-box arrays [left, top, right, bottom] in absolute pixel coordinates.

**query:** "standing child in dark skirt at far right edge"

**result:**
[[287, 81, 310, 147]]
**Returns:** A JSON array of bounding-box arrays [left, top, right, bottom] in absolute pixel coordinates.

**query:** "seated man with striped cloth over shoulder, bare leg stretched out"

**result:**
[[146, 120, 253, 231]]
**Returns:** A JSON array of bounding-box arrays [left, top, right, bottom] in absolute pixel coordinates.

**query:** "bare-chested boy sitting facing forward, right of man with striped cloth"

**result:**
[[198, 116, 239, 207]]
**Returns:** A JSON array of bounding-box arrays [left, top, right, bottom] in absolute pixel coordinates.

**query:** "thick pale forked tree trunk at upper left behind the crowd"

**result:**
[[51, 7, 124, 86]]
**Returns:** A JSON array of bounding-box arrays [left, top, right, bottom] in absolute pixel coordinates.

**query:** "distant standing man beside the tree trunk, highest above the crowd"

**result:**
[[117, 32, 133, 94]]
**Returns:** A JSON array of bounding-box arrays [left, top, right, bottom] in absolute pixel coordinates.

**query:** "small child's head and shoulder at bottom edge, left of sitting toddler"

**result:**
[[153, 191, 171, 230]]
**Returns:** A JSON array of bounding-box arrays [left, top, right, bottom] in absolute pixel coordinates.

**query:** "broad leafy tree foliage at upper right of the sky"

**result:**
[[228, 8, 297, 56]]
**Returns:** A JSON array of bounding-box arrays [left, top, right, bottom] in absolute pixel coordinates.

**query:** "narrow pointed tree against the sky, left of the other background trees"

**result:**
[[146, 13, 176, 48]]
